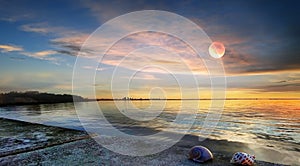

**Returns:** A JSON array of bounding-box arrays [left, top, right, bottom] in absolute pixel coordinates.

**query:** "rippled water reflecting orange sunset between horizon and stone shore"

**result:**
[[0, 100, 300, 162]]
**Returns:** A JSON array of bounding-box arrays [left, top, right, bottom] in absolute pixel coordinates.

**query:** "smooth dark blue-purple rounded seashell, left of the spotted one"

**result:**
[[189, 146, 213, 163]]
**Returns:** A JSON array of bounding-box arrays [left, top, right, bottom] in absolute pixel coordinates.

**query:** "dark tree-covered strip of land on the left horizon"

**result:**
[[0, 91, 89, 106]]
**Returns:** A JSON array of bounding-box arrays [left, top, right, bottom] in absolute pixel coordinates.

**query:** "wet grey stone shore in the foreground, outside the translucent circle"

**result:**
[[0, 118, 286, 166]]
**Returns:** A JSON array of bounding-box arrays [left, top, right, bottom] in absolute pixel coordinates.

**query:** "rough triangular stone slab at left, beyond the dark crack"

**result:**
[[0, 118, 88, 157]]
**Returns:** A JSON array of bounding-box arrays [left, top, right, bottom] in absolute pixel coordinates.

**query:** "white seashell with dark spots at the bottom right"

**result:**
[[230, 152, 255, 166]]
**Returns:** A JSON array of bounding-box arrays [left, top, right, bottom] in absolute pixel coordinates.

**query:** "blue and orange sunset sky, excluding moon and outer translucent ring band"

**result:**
[[0, 0, 300, 98]]
